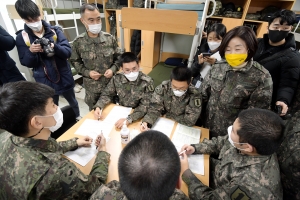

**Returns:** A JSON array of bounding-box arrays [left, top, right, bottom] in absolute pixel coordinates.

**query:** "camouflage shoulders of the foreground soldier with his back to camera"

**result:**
[[90, 181, 189, 200]]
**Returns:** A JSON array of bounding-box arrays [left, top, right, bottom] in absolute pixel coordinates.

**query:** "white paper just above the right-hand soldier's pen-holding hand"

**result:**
[[172, 124, 201, 151]]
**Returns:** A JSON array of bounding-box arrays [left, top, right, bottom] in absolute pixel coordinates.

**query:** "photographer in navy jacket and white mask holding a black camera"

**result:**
[[15, 0, 81, 119]]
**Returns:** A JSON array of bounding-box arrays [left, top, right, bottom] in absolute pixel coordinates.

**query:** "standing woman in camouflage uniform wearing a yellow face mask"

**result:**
[[200, 27, 273, 137]]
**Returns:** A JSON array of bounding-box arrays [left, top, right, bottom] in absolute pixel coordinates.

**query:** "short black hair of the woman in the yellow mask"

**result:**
[[219, 26, 258, 62]]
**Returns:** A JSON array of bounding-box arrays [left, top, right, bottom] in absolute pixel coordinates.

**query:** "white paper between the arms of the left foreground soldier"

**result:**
[[64, 144, 97, 166]]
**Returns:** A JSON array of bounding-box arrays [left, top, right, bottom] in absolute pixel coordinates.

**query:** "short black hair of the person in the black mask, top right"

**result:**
[[268, 9, 296, 26]]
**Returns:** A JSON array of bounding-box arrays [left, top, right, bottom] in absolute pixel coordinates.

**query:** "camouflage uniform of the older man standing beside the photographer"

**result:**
[[70, 32, 120, 110]]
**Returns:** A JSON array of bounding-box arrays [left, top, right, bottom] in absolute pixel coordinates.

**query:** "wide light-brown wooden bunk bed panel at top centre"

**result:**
[[122, 8, 198, 35]]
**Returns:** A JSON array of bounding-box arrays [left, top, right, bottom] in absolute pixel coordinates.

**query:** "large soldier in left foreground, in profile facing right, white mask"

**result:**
[[0, 81, 110, 200]]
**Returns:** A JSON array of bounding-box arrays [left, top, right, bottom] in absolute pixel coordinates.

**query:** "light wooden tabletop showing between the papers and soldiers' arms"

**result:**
[[57, 104, 209, 195]]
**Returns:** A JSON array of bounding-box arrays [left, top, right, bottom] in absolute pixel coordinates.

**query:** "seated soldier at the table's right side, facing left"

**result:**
[[181, 108, 284, 200]]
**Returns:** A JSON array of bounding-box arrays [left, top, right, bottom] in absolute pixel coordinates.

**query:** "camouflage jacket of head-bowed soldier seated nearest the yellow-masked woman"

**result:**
[[143, 81, 201, 126]]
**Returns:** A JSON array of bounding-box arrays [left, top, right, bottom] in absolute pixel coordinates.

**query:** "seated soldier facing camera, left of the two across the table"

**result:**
[[94, 52, 154, 128]]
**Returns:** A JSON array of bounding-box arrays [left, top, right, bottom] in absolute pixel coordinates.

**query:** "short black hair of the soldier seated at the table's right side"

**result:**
[[237, 108, 284, 155]]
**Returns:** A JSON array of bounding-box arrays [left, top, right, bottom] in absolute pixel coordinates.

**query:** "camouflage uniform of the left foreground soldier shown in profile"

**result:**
[[0, 133, 110, 200]]
